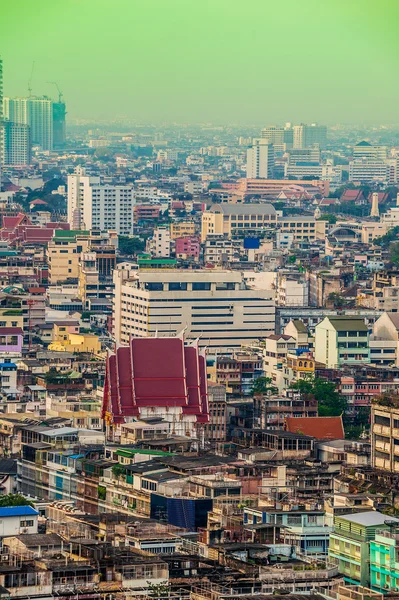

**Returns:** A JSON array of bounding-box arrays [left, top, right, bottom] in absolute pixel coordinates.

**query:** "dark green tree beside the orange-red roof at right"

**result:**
[[291, 377, 347, 417]]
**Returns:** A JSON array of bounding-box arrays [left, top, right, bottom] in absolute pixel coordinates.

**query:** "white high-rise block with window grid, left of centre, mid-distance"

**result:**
[[68, 167, 135, 235]]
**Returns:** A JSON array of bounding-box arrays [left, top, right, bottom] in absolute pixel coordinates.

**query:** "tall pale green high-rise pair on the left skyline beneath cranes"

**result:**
[[3, 96, 53, 150]]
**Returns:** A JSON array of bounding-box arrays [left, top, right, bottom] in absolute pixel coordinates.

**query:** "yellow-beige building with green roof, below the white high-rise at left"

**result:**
[[47, 229, 89, 285]]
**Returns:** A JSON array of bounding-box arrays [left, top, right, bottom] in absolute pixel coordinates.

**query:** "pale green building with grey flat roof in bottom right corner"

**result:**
[[328, 510, 399, 585]]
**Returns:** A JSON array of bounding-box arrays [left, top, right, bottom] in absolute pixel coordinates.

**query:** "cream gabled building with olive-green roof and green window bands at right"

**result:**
[[315, 316, 370, 369]]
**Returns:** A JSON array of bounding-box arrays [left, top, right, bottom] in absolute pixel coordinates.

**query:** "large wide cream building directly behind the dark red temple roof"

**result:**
[[113, 265, 274, 353]]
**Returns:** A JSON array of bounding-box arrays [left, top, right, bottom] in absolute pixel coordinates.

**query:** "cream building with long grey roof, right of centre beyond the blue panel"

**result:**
[[201, 204, 277, 242]]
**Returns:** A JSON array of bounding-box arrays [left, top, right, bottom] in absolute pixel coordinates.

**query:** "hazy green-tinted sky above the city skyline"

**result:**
[[0, 0, 399, 124]]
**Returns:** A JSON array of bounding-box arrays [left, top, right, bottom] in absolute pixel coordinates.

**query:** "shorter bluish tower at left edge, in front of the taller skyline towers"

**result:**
[[1, 121, 32, 167]]
